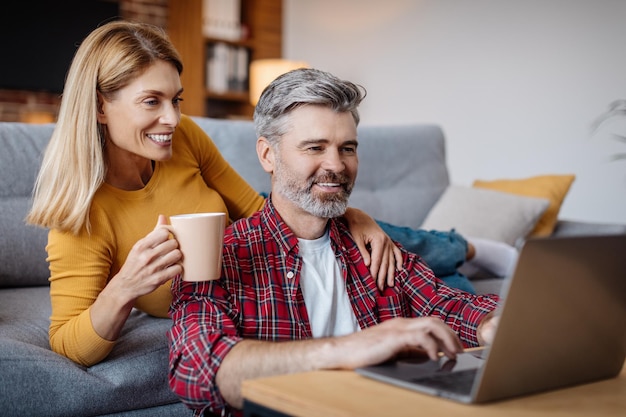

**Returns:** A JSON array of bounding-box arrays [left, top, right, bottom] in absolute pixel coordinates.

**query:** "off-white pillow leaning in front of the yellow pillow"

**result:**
[[421, 185, 549, 246]]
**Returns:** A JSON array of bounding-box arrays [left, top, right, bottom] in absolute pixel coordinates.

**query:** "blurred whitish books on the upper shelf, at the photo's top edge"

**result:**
[[202, 0, 242, 41]]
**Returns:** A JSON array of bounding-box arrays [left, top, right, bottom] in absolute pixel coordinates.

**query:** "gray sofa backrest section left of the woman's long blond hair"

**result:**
[[0, 122, 54, 287]]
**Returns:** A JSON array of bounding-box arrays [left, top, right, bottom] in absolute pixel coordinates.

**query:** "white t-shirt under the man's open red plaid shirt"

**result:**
[[298, 231, 360, 337]]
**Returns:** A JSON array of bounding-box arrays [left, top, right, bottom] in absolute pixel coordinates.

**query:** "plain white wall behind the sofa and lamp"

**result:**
[[284, 0, 626, 223]]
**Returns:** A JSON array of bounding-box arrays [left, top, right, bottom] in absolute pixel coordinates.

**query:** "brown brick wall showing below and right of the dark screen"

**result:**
[[0, 0, 168, 123]]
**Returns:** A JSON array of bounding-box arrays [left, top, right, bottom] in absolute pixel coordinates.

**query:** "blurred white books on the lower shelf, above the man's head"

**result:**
[[206, 42, 250, 94]]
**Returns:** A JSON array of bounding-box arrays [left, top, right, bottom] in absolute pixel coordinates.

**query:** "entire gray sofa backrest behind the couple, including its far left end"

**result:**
[[0, 117, 449, 287]]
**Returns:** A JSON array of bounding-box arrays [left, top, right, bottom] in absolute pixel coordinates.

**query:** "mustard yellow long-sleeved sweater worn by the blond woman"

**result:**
[[46, 116, 264, 365]]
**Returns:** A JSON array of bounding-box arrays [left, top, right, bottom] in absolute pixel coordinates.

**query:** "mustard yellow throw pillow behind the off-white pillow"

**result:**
[[473, 175, 576, 236]]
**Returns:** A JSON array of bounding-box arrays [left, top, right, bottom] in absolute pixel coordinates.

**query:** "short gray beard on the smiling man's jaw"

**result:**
[[274, 161, 352, 219]]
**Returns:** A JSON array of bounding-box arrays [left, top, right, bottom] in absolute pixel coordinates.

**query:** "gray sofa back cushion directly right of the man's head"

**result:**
[[350, 124, 449, 228]]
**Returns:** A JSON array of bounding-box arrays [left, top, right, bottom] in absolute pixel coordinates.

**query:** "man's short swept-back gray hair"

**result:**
[[254, 68, 367, 145]]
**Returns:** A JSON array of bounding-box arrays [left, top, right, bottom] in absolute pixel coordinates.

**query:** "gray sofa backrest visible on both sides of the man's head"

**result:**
[[193, 117, 449, 227]]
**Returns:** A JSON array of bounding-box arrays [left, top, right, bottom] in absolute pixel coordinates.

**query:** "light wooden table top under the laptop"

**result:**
[[242, 366, 626, 417]]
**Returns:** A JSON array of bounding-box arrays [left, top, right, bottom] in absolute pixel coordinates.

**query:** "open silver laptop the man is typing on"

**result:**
[[356, 235, 626, 403]]
